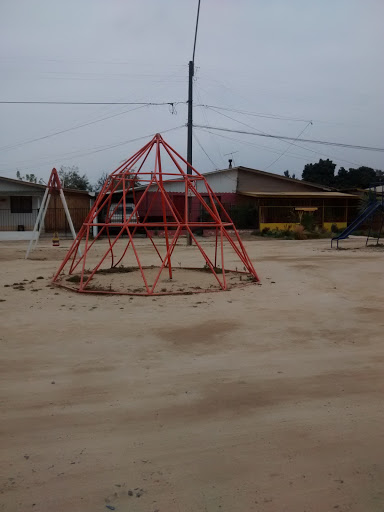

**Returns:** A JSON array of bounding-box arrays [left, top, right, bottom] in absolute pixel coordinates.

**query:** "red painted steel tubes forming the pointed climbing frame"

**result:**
[[51, 134, 259, 295]]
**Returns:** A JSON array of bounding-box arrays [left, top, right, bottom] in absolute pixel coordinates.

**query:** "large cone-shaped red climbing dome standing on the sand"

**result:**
[[53, 134, 259, 295]]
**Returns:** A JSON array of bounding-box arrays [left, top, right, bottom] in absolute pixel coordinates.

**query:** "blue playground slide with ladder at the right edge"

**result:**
[[331, 182, 384, 249]]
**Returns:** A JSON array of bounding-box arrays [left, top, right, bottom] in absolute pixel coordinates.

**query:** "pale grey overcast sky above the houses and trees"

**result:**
[[0, 0, 384, 182]]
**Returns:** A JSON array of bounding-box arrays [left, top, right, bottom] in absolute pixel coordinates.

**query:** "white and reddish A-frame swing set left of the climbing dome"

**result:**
[[25, 168, 76, 259]]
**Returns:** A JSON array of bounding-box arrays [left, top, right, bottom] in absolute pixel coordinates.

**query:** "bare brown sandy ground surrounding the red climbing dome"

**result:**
[[0, 239, 384, 512]]
